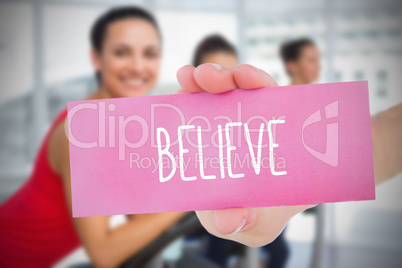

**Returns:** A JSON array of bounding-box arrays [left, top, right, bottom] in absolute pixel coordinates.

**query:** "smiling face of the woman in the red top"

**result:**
[[92, 19, 161, 98]]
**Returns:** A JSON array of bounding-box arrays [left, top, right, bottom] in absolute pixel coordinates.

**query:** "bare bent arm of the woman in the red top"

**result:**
[[48, 124, 184, 267]]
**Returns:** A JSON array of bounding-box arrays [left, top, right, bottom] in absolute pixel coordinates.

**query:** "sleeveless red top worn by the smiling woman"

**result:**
[[0, 110, 80, 267]]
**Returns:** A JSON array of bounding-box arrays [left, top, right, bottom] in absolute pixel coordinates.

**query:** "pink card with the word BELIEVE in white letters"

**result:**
[[68, 82, 375, 217]]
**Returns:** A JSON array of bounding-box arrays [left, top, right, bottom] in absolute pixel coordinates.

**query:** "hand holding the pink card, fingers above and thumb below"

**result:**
[[177, 63, 312, 247]]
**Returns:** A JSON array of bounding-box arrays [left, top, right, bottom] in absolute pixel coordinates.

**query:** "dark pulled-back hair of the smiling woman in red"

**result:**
[[90, 6, 161, 83]]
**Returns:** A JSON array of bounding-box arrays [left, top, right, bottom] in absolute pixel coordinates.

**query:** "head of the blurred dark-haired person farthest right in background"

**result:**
[[280, 38, 321, 85]]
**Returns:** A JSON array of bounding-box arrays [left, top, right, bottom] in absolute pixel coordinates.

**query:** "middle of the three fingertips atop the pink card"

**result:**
[[194, 63, 238, 93]]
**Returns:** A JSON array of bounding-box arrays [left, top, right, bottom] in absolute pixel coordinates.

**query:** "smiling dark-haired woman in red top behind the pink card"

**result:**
[[0, 7, 183, 267]]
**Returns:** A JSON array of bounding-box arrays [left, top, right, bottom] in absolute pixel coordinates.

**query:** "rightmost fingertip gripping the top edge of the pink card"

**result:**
[[233, 64, 278, 89]]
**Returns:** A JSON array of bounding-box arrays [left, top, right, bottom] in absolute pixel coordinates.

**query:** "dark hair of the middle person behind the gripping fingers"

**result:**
[[193, 34, 237, 67]]
